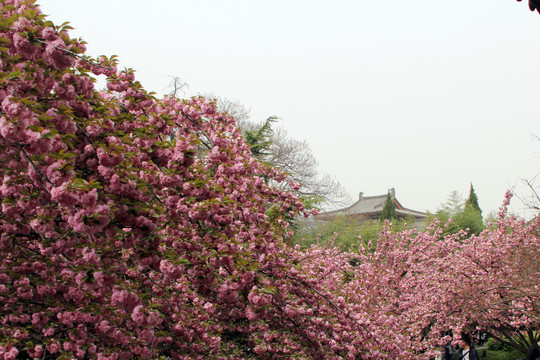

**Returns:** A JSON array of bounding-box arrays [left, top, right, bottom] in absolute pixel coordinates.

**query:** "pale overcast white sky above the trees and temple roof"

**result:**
[[38, 0, 540, 217]]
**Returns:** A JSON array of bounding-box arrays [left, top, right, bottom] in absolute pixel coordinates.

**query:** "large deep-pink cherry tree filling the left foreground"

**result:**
[[0, 0, 376, 359]]
